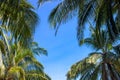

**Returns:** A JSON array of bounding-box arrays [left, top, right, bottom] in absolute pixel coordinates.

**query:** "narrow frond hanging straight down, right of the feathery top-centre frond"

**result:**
[[77, 0, 94, 40]]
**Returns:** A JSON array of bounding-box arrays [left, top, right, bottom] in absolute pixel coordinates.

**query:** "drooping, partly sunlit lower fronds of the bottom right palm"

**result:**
[[67, 52, 120, 80]]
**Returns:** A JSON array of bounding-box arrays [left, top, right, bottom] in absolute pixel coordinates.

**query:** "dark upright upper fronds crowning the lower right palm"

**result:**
[[79, 27, 115, 52]]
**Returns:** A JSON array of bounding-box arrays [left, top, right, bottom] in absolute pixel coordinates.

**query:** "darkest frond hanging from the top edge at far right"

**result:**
[[96, 0, 119, 41]]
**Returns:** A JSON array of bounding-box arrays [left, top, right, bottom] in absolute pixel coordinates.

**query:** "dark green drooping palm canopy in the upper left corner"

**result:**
[[0, 0, 38, 45]]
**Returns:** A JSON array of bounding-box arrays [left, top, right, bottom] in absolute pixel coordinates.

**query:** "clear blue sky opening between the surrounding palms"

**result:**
[[29, 0, 90, 80]]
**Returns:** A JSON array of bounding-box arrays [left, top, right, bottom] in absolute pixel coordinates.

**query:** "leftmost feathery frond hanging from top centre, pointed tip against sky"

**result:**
[[49, 0, 81, 33]]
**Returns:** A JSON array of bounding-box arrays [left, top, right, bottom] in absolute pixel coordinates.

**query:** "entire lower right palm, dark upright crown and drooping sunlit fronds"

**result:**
[[67, 28, 120, 80]]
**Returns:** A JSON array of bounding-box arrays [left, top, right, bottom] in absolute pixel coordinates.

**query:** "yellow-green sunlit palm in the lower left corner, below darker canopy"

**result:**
[[0, 42, 50, 80]]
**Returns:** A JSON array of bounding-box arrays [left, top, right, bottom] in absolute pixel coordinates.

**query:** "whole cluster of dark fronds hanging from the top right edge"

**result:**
[[49, 0, 120, 40]]
